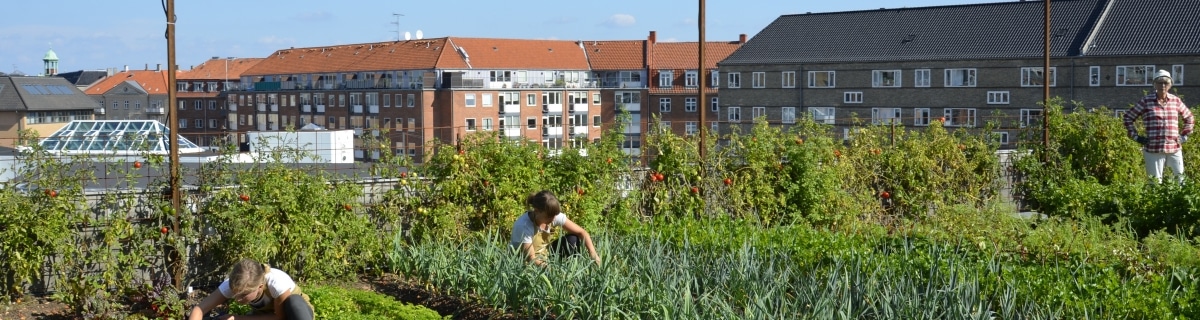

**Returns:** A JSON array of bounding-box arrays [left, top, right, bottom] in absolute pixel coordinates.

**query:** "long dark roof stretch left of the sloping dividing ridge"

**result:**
[[721, 0, 1104, 65]]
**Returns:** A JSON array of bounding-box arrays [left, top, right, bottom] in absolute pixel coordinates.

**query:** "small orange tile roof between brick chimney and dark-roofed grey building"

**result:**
[[649, 41, 742, 70]]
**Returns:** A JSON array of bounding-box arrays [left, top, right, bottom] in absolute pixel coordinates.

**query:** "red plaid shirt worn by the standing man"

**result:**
[[1124, 93, 1194, 153]]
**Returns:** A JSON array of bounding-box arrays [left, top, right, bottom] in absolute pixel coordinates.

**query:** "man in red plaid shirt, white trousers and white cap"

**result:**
[[1124, 70, 1193, 182]]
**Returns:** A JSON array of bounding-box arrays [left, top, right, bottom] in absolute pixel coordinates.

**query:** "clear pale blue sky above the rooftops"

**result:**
[[0, 0, 1016, 76]]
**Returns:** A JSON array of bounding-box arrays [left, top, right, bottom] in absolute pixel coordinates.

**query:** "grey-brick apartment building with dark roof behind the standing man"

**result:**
[[719, 0, 1200, 147]]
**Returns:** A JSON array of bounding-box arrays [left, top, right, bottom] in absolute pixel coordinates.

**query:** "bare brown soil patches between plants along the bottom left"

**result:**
[[0, 274, 530, 320]]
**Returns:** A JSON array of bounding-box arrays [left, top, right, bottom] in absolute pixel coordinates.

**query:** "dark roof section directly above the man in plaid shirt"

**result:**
[[1084, 0, 1200, 55]]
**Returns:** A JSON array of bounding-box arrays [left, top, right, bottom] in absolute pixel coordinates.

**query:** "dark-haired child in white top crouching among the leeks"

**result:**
[[509, 191, 600, 266]]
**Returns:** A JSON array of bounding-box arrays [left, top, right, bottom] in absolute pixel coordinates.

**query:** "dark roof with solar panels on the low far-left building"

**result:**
[[0, 77, 97, 111]]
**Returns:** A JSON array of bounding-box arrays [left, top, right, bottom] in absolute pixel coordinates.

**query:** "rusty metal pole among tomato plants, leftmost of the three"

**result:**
[[167, 0, 184, 289]]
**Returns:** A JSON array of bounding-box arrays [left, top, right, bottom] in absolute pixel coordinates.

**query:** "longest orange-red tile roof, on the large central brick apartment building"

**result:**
[[242, 37, 588, 76]]
